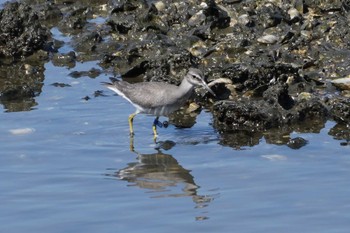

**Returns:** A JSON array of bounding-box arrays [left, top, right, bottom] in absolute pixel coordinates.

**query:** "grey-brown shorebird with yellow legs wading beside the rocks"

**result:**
[[103, 68, 215, 138]]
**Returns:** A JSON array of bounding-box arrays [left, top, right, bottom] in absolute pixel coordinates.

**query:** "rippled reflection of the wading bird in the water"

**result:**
[[109, 137, 214, 220]]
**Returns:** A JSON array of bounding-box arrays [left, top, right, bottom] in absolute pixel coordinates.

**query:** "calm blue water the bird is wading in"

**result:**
[[0, 22, 350, 233]]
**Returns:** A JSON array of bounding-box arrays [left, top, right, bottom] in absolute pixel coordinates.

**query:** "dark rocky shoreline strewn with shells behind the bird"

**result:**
[[0, 0, 350, 148]]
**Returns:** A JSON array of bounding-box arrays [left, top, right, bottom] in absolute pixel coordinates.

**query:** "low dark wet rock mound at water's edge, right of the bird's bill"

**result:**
[[213, 86, 329, 131]]
